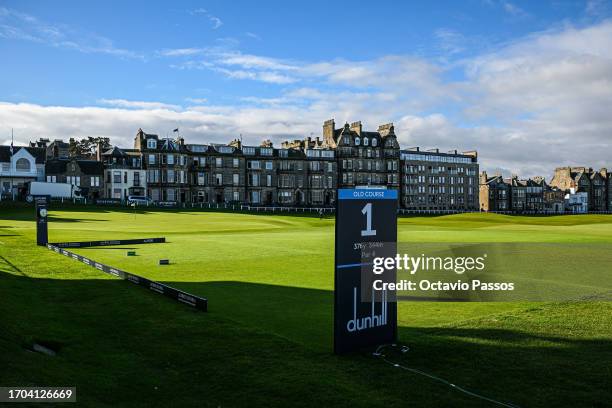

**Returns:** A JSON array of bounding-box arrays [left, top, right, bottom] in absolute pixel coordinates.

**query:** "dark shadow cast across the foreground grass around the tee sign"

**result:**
[[0, 273, 612, 407]]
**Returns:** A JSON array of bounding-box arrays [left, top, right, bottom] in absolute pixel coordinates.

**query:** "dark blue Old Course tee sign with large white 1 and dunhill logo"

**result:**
[[334, 189, 397, 354]]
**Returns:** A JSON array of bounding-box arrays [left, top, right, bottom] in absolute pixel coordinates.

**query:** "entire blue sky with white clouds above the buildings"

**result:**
[[0, 0, 612, 178]]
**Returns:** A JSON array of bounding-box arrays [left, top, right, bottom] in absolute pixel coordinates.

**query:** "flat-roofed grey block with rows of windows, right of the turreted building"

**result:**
[[400, 147, 478, 211]]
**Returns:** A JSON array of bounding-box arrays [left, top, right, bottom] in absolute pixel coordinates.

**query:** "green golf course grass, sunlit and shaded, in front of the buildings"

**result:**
[[0, 207, 612, 407]]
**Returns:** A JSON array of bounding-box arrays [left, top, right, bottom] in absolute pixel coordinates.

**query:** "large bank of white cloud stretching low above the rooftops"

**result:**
[[0, 16, 612, 176]]
